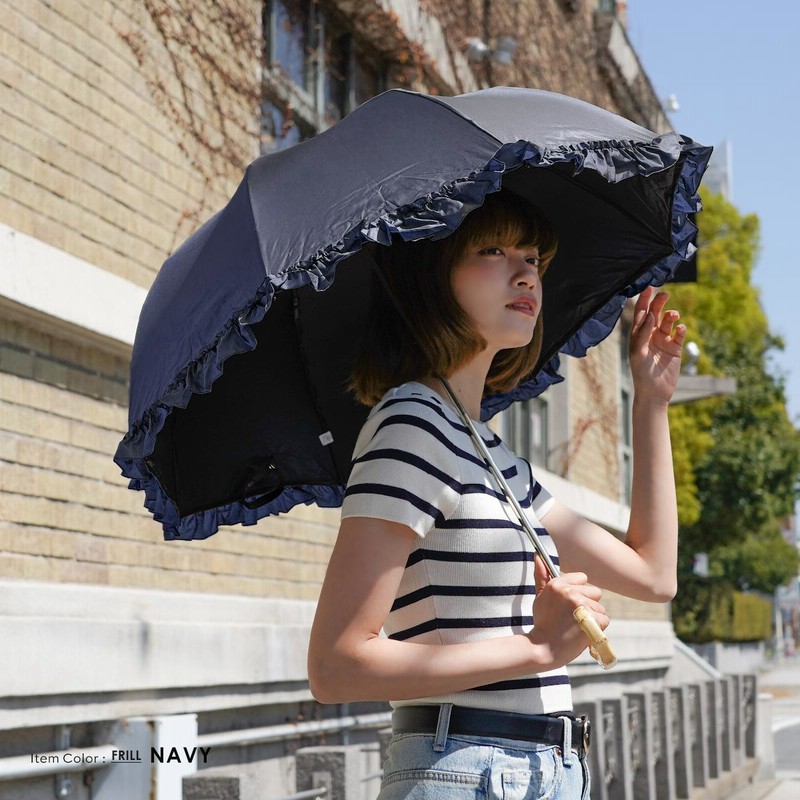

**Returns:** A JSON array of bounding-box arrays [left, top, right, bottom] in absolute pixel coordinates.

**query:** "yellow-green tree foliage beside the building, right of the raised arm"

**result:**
[[669, 195, 800, 608]]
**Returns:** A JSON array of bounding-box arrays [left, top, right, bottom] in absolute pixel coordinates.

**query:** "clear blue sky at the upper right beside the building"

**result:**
[[628, 0, 800, 426]]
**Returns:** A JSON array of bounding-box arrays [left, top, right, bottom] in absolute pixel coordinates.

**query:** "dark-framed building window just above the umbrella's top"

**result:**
[[261, 0, 386, 153]]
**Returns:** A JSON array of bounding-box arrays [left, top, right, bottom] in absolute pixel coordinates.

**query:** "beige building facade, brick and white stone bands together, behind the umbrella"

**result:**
[[0, 0, 671, 797]]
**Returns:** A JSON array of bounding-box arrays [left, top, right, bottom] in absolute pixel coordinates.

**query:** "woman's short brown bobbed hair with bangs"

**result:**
[[350, 190, 557, 406]]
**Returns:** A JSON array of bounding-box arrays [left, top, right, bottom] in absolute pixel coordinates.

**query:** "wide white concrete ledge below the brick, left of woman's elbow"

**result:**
[[0, 580, 315, 707]]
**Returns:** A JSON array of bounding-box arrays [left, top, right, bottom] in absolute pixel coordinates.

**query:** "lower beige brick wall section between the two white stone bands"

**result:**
[[0, 306, 336, 600]]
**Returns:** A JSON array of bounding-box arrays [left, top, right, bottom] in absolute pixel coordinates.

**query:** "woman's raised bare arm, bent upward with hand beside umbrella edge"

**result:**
[[544, 289, 686, 602]]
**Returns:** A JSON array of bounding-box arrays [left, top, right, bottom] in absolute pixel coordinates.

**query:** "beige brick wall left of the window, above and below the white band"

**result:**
[[0, 0, 344, 600]]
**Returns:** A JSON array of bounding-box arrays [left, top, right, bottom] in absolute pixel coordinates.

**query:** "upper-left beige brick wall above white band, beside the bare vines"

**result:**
[[0, 0, 250, 287]]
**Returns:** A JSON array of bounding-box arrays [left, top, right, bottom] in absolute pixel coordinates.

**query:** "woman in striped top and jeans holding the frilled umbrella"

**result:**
[[309, 191, 686, 800]]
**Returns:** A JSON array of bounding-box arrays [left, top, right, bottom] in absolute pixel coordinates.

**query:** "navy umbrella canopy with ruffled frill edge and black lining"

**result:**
[[115, 88, 711, 539]]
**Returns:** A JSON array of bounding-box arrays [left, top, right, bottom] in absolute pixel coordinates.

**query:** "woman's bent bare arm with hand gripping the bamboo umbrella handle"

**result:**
[[308, 517, 608, 703]]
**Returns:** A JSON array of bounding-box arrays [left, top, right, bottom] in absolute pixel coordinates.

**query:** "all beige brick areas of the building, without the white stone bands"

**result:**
[[0, 0, 664, 599]]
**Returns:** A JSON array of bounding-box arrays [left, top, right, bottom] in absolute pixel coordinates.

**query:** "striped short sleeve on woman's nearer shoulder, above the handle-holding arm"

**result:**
[[342, 399, 461, 537]]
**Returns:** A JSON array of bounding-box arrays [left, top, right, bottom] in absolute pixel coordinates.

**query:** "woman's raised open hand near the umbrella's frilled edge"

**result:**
[[628, 286, 686, 403]]
